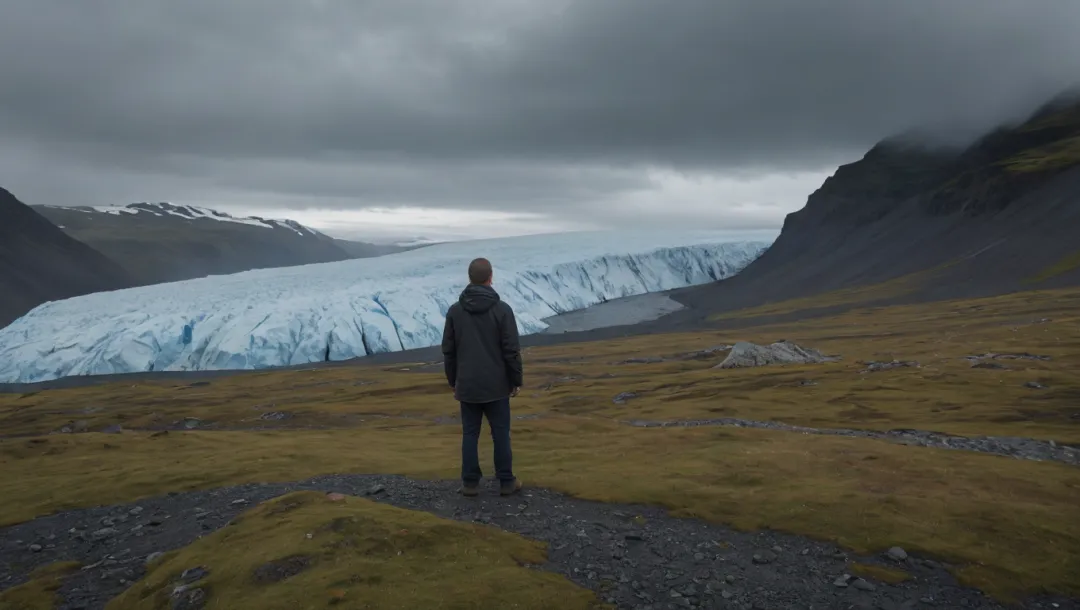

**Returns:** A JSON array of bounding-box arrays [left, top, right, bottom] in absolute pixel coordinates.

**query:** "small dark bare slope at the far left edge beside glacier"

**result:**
[[0, 188, 132, 327]]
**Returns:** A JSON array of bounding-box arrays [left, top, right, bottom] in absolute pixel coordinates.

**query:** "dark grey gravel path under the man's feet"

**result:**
[[0, 475, 1080, 610]]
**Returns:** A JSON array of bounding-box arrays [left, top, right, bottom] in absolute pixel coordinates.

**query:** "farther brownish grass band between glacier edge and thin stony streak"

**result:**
[[0, 282, 1080, 443]]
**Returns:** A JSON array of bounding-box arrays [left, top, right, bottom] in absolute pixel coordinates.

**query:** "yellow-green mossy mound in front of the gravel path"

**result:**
[[107, 491, 600, 610]]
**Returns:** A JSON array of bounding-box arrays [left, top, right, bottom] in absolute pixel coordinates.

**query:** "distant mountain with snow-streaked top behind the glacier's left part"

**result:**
[[37, 203, 403, 284]]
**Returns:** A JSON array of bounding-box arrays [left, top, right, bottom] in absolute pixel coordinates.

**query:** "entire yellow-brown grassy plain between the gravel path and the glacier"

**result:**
[[0, 289, 1080, 596]]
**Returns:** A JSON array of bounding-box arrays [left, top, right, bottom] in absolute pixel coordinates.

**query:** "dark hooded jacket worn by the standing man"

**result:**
[[443, 284, 522, 403]]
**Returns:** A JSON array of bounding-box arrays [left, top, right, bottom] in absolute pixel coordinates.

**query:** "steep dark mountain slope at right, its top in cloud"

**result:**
[[676, 99, 1080, 311]]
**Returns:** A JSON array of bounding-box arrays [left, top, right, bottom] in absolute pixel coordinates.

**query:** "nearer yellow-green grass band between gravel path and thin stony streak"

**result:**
[[0, 418, 1080, 595]]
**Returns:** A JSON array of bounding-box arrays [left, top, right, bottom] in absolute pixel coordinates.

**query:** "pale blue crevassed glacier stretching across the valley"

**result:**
[[0, 231, 773, 383]]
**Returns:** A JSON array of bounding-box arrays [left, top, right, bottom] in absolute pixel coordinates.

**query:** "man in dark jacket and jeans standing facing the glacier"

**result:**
[[443, 258, 522, 497]]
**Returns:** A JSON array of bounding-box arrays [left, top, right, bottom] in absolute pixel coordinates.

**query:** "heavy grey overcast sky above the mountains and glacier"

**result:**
[[0, 0, 1080, 239]]
